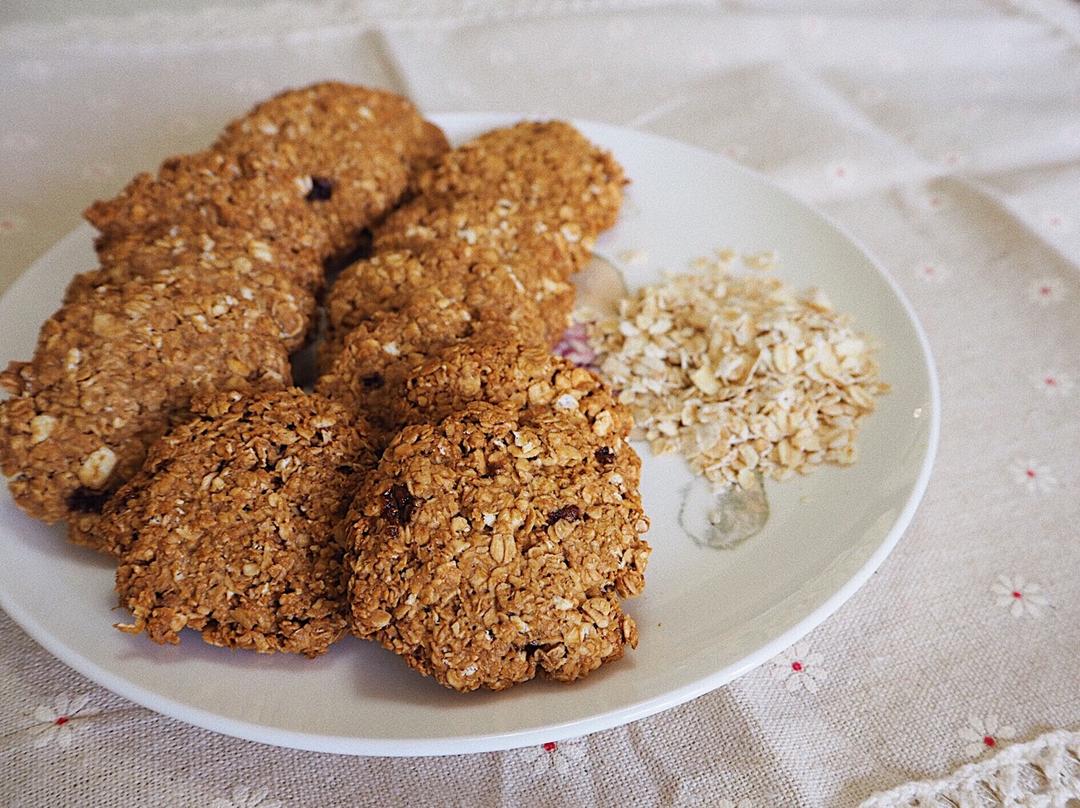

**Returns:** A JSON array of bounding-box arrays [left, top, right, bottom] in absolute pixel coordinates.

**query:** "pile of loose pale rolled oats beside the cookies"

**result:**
[[590, 260, 888, 488]]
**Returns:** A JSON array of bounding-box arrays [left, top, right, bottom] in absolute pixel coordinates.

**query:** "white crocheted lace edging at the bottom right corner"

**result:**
[[861, 730, 1080, 808]]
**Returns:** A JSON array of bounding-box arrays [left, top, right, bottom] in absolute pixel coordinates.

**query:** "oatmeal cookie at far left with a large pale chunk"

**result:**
[[0, 274, 289, 535]]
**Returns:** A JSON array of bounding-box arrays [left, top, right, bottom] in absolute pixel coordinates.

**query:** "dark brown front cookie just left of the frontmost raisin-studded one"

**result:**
[[109, 389, 374, 657]]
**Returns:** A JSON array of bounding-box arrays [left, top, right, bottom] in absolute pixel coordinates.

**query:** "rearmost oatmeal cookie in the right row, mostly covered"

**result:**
[[415, 121, 626, 240]]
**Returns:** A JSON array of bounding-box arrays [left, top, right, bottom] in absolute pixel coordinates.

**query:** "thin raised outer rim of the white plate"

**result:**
[[0, 111, 941, 757]]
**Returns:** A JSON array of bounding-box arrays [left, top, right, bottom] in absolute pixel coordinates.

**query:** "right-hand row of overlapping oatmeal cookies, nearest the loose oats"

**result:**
[[315, 122, 649, 690]]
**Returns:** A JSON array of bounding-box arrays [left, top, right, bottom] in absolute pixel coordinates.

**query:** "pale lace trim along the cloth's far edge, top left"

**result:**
[[0, 0, 691, 53]]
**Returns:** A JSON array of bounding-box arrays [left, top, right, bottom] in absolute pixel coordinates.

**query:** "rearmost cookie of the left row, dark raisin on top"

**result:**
[[85, 83, 446, 257]]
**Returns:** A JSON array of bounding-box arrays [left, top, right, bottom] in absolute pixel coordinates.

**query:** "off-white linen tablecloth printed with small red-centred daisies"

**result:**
[[0, 0, 1080, 808]]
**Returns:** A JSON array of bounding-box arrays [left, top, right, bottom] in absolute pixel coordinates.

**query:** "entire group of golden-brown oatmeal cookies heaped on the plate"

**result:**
[[0, 90, 649, 690]]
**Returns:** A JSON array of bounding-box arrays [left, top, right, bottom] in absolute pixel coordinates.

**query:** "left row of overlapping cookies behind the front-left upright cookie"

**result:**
[[0, 83, 447, 547]]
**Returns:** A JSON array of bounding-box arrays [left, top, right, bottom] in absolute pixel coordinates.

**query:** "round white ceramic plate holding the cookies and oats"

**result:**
[[0, 115, 939, 755]]
